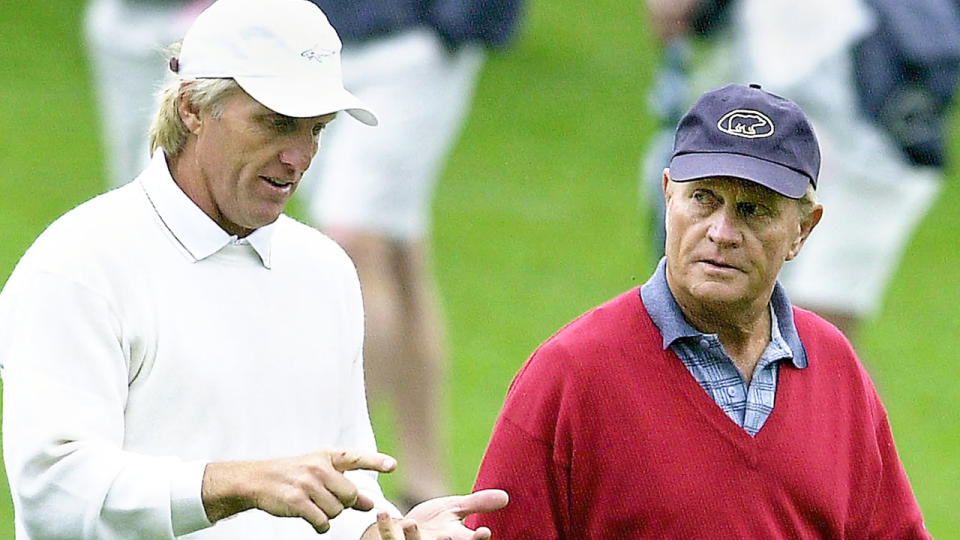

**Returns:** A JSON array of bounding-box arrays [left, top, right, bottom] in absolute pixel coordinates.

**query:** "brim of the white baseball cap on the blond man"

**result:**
[[236, 77, 379, 126]]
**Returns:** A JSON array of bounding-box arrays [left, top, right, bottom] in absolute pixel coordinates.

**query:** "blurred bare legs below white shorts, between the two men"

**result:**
[[328, 229, 449, 502]]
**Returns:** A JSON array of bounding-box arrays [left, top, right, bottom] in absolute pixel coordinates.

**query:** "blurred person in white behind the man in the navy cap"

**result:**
[[641, 0, 960, 340]]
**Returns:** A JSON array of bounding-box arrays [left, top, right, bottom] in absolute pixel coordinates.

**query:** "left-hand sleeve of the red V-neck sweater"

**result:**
[[467, 349, 570, 540]]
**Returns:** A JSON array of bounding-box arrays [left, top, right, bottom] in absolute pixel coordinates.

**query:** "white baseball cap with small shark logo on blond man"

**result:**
[[177, 0, 377, 126]]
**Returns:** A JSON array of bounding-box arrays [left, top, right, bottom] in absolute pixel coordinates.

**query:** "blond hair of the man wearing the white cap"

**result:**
[[150, 43, 240, 157]]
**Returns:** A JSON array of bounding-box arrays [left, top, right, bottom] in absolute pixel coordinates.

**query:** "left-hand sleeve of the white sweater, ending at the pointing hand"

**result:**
[[0, 271, 210, 539]]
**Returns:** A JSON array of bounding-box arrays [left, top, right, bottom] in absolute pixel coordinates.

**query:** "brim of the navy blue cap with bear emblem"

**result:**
[[670, 152, 810, 199]]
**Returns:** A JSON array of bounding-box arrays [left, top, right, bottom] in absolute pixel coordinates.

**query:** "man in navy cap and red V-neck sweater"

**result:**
[[468, 85, 929, 539]]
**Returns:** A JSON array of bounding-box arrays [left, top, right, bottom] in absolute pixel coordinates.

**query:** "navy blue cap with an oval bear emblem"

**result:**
[[670, 84, 820, 199]]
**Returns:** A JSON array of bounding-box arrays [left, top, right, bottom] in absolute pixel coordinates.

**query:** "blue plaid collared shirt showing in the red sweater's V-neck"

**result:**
[[640, 259, 807, 436]]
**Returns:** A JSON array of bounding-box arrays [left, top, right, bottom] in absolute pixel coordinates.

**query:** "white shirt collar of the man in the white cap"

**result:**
[[137, 152, 276, 268]]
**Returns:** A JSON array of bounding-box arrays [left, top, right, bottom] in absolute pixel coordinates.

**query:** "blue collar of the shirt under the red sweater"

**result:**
[[640, 257, 807, 369]]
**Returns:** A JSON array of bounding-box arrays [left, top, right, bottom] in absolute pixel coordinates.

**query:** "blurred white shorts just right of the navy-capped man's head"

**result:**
[[780, 50, 940, 318]]
